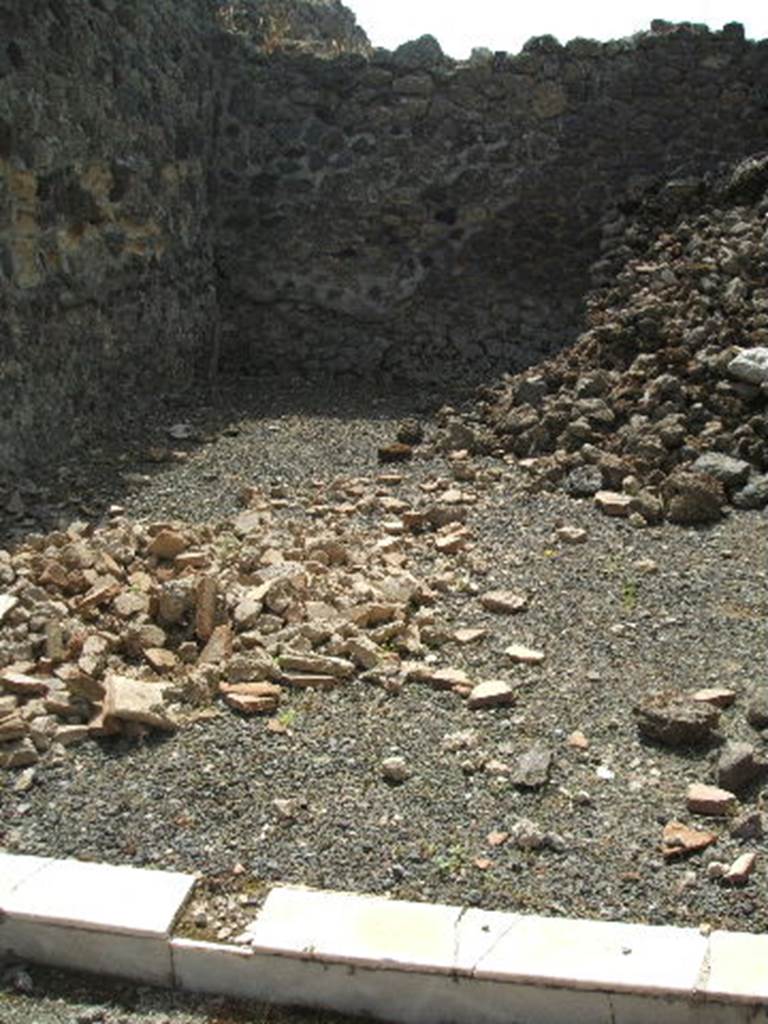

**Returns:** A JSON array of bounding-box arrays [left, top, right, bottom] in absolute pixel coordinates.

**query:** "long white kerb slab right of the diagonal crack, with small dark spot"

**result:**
[[475, 918, 708, 996]]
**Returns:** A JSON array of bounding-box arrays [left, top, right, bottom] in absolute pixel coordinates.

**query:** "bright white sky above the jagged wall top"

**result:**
[[345, 0, 768, 59]]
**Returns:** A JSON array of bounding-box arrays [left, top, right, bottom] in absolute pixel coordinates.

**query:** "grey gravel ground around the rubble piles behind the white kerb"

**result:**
[[0, 380, 768, 1011]]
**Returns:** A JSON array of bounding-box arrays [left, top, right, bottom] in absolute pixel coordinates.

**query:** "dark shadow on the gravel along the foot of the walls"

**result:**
[[0, 378, 477, 547]]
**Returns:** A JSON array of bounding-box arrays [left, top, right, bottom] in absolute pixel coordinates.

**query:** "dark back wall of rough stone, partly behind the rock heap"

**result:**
[[216, 25, 768, 380]]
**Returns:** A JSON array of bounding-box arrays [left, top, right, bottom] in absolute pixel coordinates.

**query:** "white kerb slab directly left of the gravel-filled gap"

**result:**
[[3, 860, 195, 937]]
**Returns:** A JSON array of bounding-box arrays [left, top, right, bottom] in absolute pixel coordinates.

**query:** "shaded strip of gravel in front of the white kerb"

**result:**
[[0, 961, 380, 1024]]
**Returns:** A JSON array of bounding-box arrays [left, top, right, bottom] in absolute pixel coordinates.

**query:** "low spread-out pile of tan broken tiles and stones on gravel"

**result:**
[[0, 474, 525, 767]]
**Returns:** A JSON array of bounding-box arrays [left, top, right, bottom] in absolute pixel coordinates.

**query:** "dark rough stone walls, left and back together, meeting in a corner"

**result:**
[[0, 0, 768, 476]]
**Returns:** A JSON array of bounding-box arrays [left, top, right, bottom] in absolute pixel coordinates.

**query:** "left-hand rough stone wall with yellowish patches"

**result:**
[[0, 0, 221, 476]]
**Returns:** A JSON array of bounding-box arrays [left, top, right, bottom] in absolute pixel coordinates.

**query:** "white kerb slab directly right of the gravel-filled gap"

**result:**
[[248, 887, 461, 972]]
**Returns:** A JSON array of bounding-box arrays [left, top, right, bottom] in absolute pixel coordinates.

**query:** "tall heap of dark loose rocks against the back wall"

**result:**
[[462, 157, 768, 525]]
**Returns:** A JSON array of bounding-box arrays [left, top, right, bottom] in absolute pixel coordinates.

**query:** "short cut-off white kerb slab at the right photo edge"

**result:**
[[701, 932, 768, 1003]]
